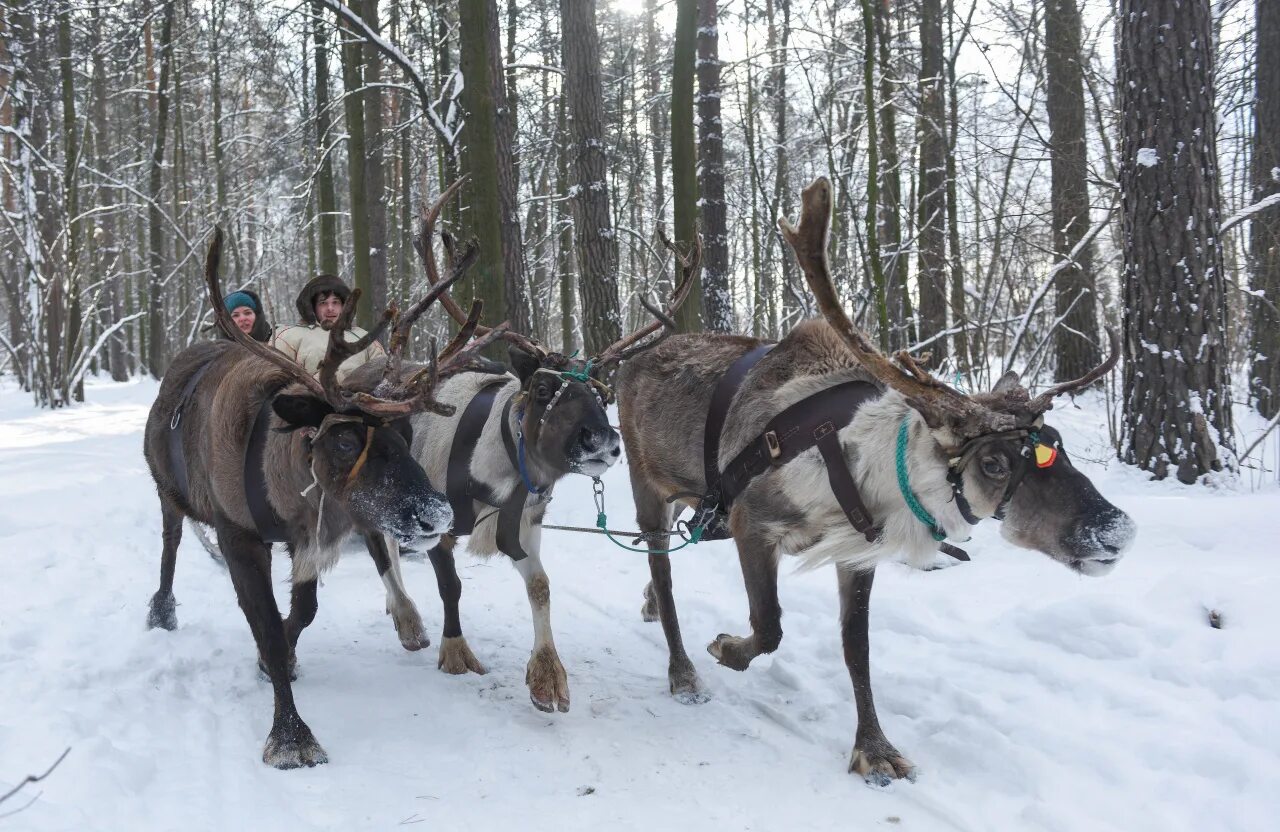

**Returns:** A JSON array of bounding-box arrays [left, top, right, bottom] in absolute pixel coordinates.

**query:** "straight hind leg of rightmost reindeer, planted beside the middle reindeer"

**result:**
[[631, 476, 710, 705]]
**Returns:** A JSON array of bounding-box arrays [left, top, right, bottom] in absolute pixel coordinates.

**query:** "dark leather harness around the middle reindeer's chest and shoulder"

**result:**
[[444, 380, 530, 561]]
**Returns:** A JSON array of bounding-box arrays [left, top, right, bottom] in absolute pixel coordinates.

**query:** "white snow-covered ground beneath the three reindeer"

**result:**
[[0, 381, 1280, 832]]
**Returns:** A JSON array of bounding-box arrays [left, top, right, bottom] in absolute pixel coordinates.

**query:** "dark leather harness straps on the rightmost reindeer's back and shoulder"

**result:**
[[692, 344, 882, 543]]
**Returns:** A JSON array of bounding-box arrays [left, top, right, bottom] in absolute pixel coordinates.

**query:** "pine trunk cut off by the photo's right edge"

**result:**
[[1249, 0, 1280, 416]]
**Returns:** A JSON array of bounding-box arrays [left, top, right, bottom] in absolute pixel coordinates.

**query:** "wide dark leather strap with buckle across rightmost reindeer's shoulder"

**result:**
[[721, 381, 882, 543]]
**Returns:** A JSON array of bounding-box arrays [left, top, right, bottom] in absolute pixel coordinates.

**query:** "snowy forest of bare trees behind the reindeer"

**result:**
[[0, 0, 1280, 483]]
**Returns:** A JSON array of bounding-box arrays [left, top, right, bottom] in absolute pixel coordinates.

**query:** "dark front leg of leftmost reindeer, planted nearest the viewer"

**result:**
[[216, 521, 329, 768]]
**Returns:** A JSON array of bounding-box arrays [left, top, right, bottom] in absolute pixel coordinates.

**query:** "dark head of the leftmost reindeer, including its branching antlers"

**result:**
[[205, 190, 506, 548]]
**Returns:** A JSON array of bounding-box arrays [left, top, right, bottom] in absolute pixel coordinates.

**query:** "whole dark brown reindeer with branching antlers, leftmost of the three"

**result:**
[[143, 230, 502, 768]]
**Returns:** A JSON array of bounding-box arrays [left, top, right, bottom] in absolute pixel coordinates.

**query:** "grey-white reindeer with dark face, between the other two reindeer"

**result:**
[[373, 193, 701, 712]]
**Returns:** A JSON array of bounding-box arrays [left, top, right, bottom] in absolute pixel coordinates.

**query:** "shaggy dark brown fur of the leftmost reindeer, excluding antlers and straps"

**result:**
[[143, 340, 453, 768]]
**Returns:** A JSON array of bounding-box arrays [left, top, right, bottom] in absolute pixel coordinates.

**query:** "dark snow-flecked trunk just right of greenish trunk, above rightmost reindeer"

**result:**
[[698, 0, 735, 333]]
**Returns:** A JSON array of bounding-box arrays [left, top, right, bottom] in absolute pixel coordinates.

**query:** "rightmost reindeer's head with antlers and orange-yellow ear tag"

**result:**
[[780, 178, 1137, 575]]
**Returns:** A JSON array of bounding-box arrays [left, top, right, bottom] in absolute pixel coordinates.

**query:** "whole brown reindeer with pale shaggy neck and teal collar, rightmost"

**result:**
[[618, 179, 1135, 783]]
